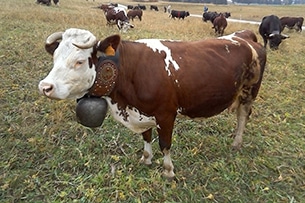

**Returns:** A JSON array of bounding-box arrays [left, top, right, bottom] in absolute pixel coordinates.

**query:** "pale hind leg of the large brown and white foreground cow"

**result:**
[[232, 101, 252, 150]]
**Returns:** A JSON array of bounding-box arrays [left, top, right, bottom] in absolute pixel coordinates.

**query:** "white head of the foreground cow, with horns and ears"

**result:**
[[38, 28, 120, 99]]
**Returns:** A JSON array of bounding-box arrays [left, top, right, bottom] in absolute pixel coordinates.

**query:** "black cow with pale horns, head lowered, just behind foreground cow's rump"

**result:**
[[259, 15, 288, 50]]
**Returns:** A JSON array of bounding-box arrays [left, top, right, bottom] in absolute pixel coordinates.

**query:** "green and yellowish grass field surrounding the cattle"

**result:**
[[0, 0, 305, 203]]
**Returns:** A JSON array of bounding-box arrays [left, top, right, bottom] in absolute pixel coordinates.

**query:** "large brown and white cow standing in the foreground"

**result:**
[[39, 28, 266, 178]]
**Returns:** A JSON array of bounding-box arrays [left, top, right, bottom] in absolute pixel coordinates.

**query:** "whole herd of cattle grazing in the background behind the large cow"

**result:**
[[36, 0, 304, 49]]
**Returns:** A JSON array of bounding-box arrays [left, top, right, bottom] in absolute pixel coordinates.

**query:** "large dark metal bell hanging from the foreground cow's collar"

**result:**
[[76, 97, 108, 128]]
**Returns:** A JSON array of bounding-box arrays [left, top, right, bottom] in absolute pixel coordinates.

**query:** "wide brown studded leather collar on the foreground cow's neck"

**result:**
[[88, 51, 119, 97]]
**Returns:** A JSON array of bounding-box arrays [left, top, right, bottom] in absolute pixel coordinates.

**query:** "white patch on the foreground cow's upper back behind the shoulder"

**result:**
[[136, 39, 180, 76]]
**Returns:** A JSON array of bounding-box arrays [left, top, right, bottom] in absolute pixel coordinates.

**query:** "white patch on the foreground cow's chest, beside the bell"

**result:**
[[105, 97, 156, 133]]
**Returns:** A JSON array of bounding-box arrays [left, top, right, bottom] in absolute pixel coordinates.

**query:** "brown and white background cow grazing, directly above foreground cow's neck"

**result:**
[[105, 7, 134, 32]]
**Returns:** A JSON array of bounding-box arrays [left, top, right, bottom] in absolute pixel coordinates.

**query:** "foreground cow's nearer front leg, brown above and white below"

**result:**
[[157, 116, 175, 179]]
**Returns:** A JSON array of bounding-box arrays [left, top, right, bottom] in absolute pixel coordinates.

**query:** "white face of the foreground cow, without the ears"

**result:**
[[39, 29, 96, 99]]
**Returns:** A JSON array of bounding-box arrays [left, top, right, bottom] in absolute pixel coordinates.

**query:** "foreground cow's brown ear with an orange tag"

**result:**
[[96, 35, 121, 56]]
